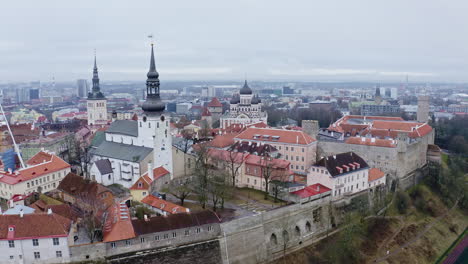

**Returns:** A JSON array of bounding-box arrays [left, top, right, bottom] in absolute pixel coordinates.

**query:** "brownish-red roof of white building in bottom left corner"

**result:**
[[0, 213, 72, 240]]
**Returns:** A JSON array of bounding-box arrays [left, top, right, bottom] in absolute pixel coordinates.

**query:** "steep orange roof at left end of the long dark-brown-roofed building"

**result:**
[[103, 202, 136, 242]]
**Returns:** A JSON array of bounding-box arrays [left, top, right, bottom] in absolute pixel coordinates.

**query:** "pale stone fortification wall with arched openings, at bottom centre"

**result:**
[[219, 200, 331, 263]]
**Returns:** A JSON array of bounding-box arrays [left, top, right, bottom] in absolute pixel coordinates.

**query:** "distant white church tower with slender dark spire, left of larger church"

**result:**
[[86, 55, 107, 126]]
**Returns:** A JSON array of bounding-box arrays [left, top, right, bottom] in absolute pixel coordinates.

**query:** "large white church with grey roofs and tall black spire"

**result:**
[[90, 46, 173, 188]]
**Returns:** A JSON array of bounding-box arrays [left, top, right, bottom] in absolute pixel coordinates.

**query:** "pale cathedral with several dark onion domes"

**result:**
[[220, 80, 268, 128]]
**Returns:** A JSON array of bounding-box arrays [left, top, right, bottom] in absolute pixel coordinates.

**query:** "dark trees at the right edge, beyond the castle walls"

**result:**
[[431, 116, 468, 157]]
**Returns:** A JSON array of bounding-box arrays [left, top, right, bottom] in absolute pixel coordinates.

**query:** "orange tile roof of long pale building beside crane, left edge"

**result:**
[[0, 155, 71, 184]]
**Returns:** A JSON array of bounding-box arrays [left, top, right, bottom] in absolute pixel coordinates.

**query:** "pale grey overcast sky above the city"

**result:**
[[0, 0, 468, 82]]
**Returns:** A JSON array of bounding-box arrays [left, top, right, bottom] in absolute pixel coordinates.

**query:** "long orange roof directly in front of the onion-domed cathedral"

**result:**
[[236, 127, 316, 145]]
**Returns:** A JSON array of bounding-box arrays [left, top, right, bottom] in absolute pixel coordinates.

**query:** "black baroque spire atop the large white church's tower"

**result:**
[[142, 44, 166, 113]]
